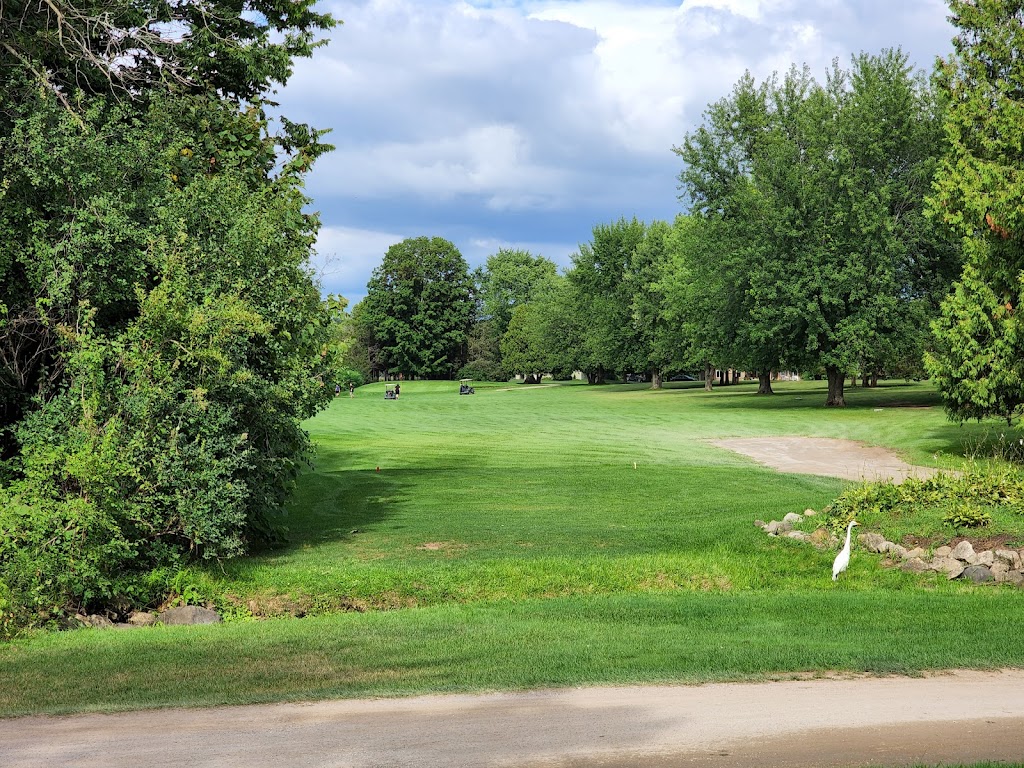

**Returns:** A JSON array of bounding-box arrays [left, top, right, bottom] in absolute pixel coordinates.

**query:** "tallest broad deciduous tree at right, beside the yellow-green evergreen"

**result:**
[[677, 50, 956, 406]]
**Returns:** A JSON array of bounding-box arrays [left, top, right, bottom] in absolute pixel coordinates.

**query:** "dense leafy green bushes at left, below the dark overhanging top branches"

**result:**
[[0, 96, 337, 635]]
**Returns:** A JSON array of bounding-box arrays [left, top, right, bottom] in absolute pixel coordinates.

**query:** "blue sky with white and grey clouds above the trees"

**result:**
[[278, 0, 952, 302]]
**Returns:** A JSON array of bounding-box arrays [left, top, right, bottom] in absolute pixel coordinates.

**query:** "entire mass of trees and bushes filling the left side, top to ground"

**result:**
[[0, 0, 335, 631]]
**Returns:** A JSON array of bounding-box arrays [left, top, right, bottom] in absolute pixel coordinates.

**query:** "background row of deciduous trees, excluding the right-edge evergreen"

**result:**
[[350, 51, 959, 397]]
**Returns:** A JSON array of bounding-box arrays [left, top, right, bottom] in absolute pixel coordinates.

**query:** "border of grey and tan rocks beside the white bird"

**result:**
[[754, 509, 1024, 588]]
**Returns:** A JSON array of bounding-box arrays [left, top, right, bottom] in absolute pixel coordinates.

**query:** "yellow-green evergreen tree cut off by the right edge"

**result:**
[[928, 0, 1024, 423]]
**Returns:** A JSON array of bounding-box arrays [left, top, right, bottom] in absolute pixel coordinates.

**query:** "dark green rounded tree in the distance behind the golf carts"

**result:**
[[358, 238, 473, 379]]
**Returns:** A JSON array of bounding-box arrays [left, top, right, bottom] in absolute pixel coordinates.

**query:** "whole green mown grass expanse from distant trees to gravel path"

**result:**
[[0, 381, 1024, 715]]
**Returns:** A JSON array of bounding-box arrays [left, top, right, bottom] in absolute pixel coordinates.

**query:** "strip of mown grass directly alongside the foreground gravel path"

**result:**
[[0, 591, 1024, 716]]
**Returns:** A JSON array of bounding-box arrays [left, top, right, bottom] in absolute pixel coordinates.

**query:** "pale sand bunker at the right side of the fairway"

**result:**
[[712, 437, 938, 482]]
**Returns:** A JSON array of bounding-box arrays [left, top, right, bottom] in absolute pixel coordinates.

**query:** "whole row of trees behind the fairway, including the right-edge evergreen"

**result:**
[[353, 0, 1024, 430]]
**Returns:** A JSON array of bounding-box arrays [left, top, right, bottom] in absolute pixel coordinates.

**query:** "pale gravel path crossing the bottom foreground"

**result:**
[[6, 670, 1024, 768]]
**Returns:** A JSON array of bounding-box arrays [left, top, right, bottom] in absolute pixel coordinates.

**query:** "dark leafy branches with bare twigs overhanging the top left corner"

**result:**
[[0, 0, 335, 105]]
